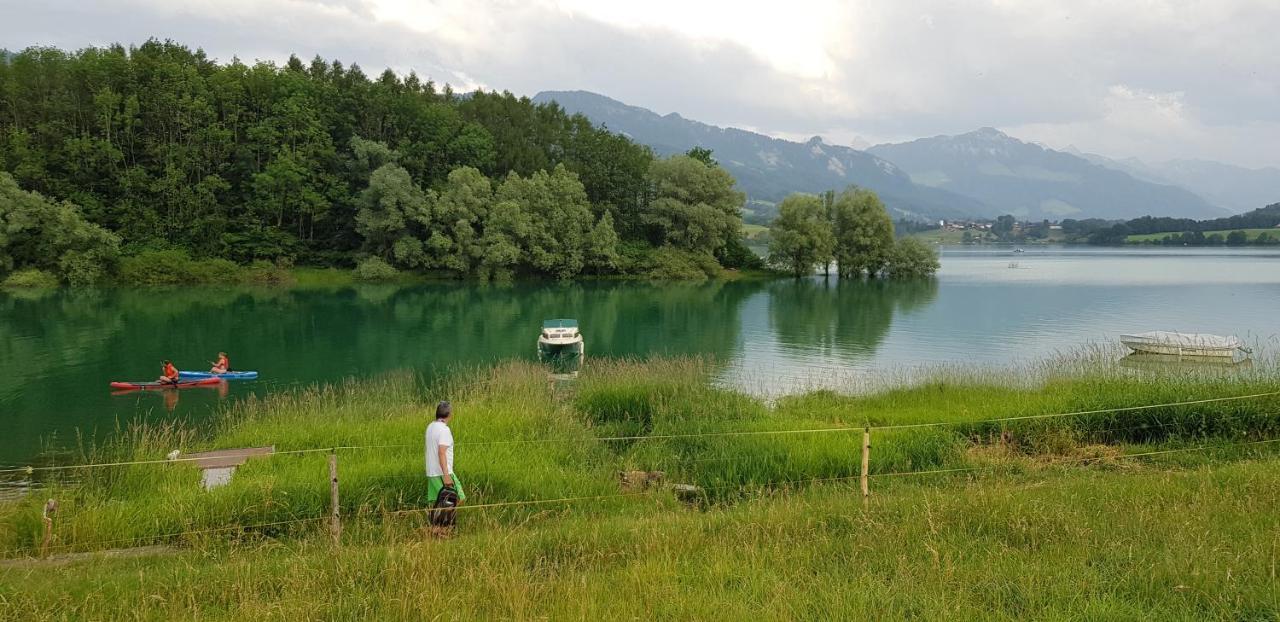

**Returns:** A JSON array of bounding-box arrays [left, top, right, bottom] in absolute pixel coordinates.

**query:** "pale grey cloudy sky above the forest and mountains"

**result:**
[[0, 0, 1280, 166]]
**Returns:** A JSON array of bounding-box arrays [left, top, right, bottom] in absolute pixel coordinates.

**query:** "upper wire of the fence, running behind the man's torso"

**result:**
[[0, 390, 1280, 475]]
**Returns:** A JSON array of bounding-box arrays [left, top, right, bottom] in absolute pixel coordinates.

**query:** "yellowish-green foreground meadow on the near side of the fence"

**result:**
[[0, 458, 1280, 621]]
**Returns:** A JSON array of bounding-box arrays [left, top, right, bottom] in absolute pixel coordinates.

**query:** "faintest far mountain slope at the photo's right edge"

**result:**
[[1076, 152, 1280, 212]]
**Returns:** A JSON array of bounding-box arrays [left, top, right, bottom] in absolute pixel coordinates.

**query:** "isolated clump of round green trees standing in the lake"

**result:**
[[769, 187, 938, 278]]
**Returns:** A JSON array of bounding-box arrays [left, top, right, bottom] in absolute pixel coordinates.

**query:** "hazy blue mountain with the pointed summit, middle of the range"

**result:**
[[868, 128, 1226, 220]]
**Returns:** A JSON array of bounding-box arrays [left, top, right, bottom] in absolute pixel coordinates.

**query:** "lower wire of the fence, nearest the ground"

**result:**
[[10, 438, 1280, 558]]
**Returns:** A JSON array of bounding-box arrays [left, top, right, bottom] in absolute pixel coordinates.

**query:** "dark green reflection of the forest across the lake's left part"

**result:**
[[0, 282, 767, 462]]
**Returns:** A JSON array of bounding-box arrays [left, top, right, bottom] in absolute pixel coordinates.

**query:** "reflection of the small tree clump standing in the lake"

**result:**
[[769, 278, 938, 358]]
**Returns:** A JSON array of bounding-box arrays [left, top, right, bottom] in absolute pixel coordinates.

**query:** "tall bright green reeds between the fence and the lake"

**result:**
[[0, 351, 1280, 557]]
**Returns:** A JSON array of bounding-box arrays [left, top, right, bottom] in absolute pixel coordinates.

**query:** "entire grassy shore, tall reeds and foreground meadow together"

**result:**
[[0, 353, 1280, 619]]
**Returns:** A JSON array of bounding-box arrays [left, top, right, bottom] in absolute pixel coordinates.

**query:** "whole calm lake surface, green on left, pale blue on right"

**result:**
[[0, 248, 1280, 465]]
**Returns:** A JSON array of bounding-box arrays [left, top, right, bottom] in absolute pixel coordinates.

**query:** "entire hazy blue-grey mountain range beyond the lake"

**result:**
[[534, 91, 1280, 220]]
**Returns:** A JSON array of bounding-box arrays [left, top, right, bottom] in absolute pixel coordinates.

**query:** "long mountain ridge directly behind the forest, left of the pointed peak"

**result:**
[[534, 91, 996, 220]]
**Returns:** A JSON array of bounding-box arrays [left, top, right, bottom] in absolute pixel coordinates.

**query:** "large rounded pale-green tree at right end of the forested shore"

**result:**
[[643, 155, 746, 253]]
